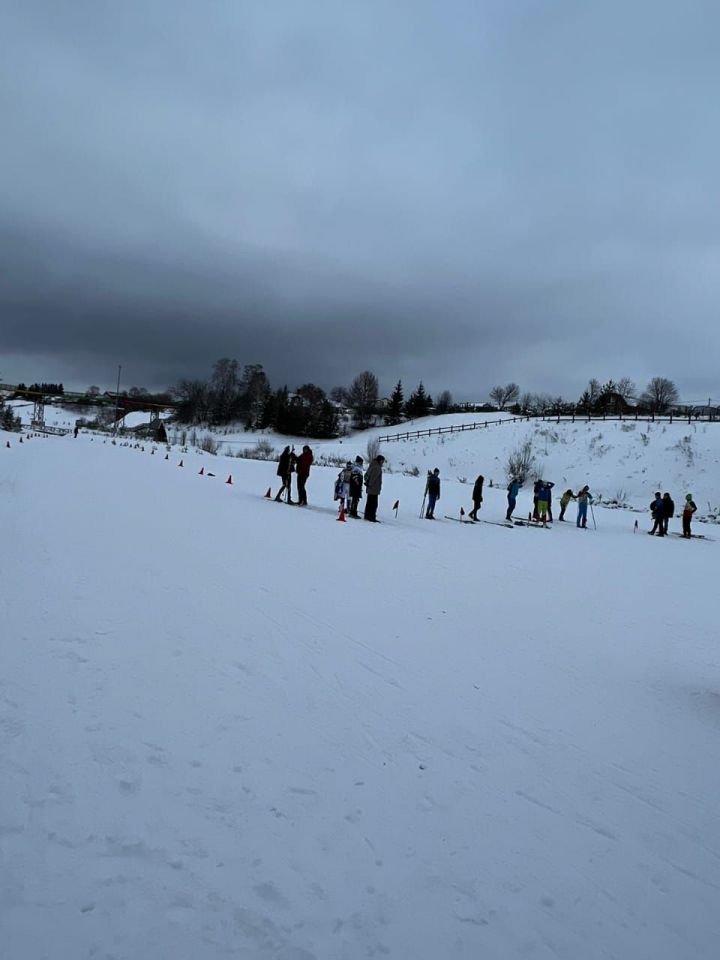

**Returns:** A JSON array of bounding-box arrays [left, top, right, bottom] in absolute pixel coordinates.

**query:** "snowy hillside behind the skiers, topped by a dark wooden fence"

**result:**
[[197, 414, 720, 514]]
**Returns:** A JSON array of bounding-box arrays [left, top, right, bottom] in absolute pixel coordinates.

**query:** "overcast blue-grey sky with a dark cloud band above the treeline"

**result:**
[[0, 0, 720, 400]]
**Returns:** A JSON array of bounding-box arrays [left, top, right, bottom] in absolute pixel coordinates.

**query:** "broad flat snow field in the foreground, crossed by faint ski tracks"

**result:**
[[0, 426, 720, 960]]
